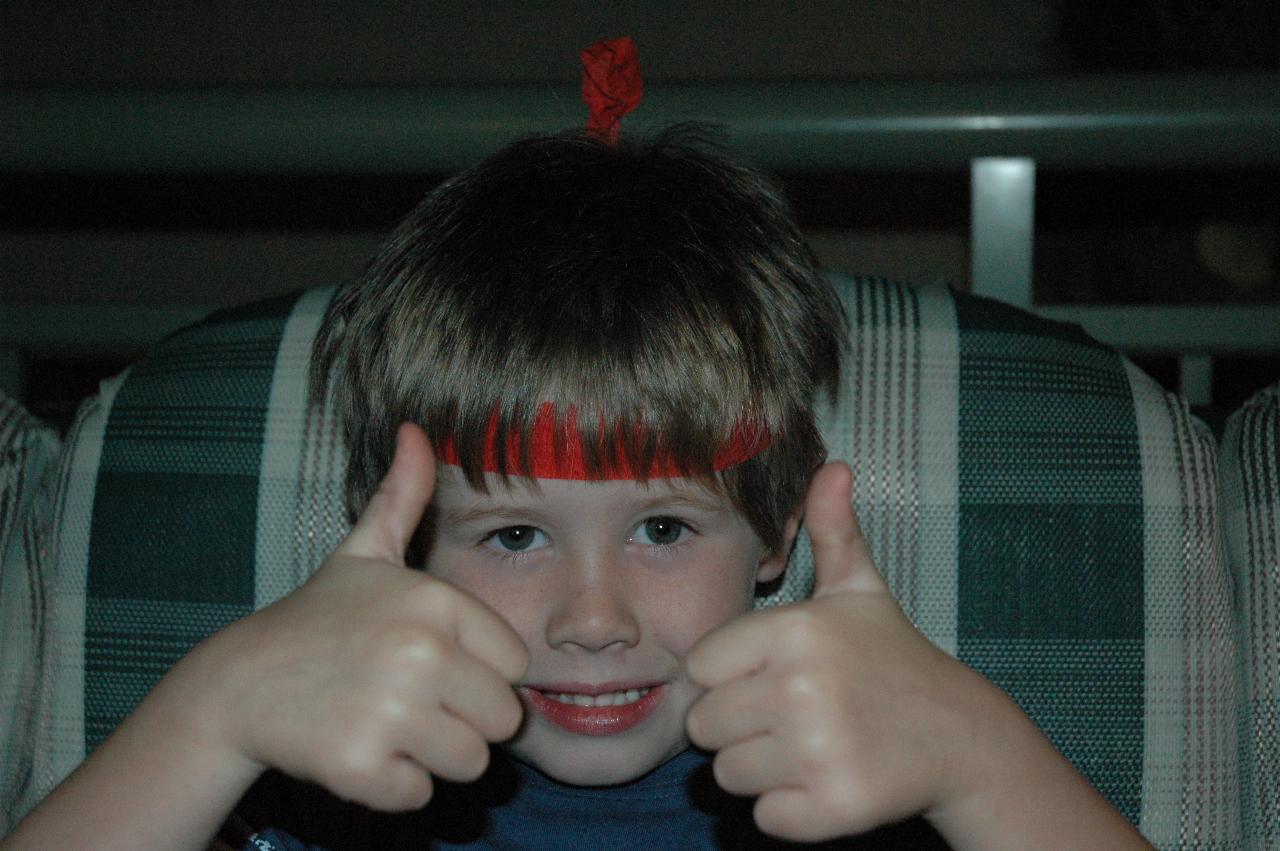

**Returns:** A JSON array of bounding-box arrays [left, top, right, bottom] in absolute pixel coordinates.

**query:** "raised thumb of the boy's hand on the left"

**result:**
[[338, 422, 435, 563]]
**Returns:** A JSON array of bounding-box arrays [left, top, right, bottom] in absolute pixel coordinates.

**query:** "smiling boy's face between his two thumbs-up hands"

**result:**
[[426, 465, 786, 786]]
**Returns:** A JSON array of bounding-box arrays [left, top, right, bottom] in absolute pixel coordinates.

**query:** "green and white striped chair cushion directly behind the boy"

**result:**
[[0, 278, 1261, 848]]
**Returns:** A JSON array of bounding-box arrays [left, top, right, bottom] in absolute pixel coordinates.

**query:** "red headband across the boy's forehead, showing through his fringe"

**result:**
[[436, 402, 772, 481]]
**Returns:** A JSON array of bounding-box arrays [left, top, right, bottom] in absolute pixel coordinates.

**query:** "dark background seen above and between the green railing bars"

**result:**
[[0, 0, 1280, 425]]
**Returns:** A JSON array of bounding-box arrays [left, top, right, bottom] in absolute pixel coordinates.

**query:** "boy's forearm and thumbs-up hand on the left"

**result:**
[[3, 426, 529, 851]]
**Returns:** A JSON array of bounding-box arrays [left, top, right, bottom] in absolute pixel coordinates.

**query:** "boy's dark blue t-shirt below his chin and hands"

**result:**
[[235, 750, 946, 851]]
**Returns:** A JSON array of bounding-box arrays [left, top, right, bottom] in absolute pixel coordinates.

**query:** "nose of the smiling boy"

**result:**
[[547, 568, 640, 651]]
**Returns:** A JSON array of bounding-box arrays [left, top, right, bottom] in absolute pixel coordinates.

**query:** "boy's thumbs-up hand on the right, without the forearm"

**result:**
[[686, 463, 1005, 841]]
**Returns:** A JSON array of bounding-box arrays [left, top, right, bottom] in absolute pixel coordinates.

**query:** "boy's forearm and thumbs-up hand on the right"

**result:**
[[687, 465, 1151, 850]]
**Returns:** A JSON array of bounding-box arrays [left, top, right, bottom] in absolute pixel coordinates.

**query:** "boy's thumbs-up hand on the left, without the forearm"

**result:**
[[174, 424, 529, 810]]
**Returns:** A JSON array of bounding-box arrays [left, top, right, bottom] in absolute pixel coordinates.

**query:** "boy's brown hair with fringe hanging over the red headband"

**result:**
[[312, 122, 846, 549]]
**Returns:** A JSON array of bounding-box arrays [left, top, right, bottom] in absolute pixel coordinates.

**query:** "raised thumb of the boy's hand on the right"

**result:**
[[804, 462, 888, 598]]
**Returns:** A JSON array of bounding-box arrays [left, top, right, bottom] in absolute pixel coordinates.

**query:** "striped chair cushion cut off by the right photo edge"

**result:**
[[1222, 384, 1280, 848]]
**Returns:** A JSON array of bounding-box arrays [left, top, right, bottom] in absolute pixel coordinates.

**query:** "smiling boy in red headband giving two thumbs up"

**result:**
[[6, 134, 1146, 848]]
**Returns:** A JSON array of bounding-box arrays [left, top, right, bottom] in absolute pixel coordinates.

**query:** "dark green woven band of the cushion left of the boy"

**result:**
[[84, 299, 292, 749]]
